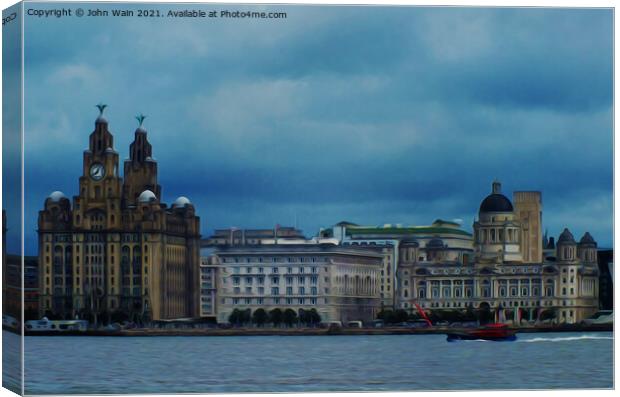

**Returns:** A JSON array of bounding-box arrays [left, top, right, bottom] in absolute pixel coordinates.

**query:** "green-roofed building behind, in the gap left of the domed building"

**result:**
[[319, 219, 474, 309]]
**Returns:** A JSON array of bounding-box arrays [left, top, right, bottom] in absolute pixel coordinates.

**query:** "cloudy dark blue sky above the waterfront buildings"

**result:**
[[7, 3, 613, 254]]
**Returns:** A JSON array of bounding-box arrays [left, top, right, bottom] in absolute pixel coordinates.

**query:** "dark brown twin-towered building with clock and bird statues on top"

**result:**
[[38, 106, 200, 321]]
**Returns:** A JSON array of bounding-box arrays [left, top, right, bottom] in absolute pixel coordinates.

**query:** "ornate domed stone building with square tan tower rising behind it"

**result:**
[[398, 182, 599, 323]]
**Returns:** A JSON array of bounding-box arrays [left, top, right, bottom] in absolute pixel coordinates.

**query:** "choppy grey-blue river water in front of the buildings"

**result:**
[[17, 332, 613, 394]]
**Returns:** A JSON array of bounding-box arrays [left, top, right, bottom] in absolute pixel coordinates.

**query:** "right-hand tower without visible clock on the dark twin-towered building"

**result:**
[[123, 116, 161, 206]]
